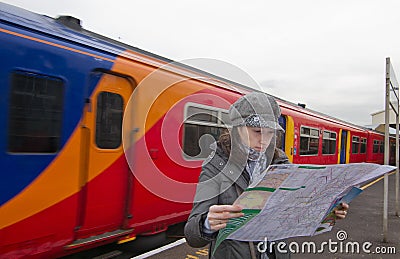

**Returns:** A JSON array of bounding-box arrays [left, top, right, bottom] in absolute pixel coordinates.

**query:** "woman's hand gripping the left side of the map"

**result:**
[[207, 205, 244, 231]]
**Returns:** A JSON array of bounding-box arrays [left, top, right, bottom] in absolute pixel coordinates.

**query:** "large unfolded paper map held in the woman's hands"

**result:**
[[216, 163, 396, 252]]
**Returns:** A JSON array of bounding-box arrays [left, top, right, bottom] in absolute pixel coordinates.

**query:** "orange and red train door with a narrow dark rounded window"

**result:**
[[76, 72, 133, 240]]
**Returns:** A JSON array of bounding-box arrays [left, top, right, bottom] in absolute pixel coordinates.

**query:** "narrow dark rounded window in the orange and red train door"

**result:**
[[96, 92, 124, 149]]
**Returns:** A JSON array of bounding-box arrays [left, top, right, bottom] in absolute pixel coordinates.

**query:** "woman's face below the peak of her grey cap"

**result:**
[[238, 127, 275, 152]]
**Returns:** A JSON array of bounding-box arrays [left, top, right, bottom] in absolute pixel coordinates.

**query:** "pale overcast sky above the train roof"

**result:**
[[3, 0, 400, 125]]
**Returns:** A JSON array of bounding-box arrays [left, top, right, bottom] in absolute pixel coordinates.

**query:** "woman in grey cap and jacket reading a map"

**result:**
[[185, 92, 348, 258]]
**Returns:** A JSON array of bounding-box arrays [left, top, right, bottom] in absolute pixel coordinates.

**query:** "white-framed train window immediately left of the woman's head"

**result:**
[[183, 103, 230, 160]]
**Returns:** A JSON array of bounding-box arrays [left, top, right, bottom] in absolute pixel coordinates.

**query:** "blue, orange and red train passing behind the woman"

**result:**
[[0, 3, 394, 258]]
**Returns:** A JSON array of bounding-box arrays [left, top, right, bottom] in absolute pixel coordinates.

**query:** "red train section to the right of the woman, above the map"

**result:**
[[278, 100, 395, 164]]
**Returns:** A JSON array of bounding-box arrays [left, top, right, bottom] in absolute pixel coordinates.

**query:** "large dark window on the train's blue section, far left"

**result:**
[[8, 72, 64, 153]]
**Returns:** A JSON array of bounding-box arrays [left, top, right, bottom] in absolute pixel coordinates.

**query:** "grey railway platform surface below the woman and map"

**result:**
[[138, 175, 400, 259]]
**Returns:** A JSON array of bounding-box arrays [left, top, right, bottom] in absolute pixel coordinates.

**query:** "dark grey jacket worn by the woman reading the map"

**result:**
[[185, 146, 290, 258]]
